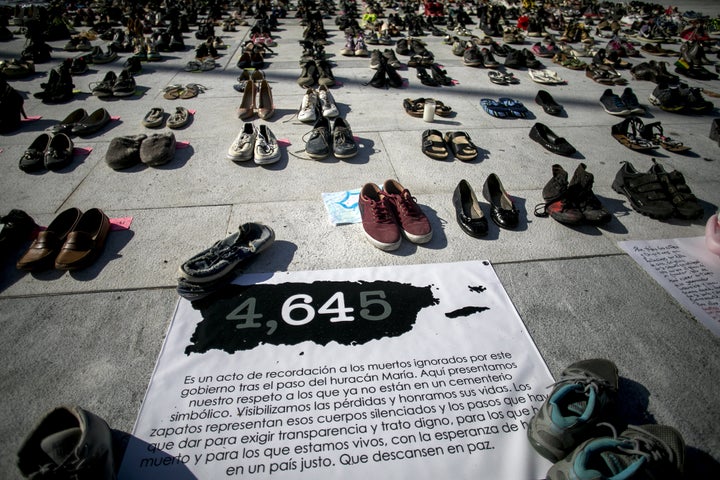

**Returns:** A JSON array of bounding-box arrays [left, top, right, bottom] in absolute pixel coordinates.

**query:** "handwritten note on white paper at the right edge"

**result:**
[[618, 237, 720, 336]]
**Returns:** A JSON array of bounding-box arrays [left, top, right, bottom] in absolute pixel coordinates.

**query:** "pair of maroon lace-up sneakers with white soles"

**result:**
[[358, 180, 432, 251]]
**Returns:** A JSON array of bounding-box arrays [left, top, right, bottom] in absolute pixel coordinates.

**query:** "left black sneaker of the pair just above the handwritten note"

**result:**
[[612, 162, 675, 220]]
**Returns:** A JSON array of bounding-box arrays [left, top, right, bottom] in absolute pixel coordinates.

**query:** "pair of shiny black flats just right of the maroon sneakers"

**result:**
[[453, 173, 520, 238]]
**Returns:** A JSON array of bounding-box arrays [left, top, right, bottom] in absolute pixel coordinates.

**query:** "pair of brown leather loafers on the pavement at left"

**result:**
[[16, 208, 110, 272]]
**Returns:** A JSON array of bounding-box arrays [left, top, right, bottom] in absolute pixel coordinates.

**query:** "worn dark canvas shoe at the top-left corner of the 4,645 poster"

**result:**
[[178, 223, 275, 283]]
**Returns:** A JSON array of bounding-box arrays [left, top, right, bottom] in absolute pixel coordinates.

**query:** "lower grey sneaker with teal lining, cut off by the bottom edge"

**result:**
[[547, 425, 685, 480]]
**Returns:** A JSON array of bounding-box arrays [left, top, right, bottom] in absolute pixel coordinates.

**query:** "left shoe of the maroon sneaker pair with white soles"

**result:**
[[358, 183, 402, 252]]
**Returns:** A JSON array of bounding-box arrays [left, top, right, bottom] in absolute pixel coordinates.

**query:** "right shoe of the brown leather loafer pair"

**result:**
[[55, 208, 110, 270]]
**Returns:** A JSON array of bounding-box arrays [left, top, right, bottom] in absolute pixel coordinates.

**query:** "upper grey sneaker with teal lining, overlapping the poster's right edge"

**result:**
[[527, 358, 618, 463]]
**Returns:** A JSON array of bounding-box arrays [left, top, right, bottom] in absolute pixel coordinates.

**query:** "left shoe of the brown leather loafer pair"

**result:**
[[16, 208, 82, 272]]
